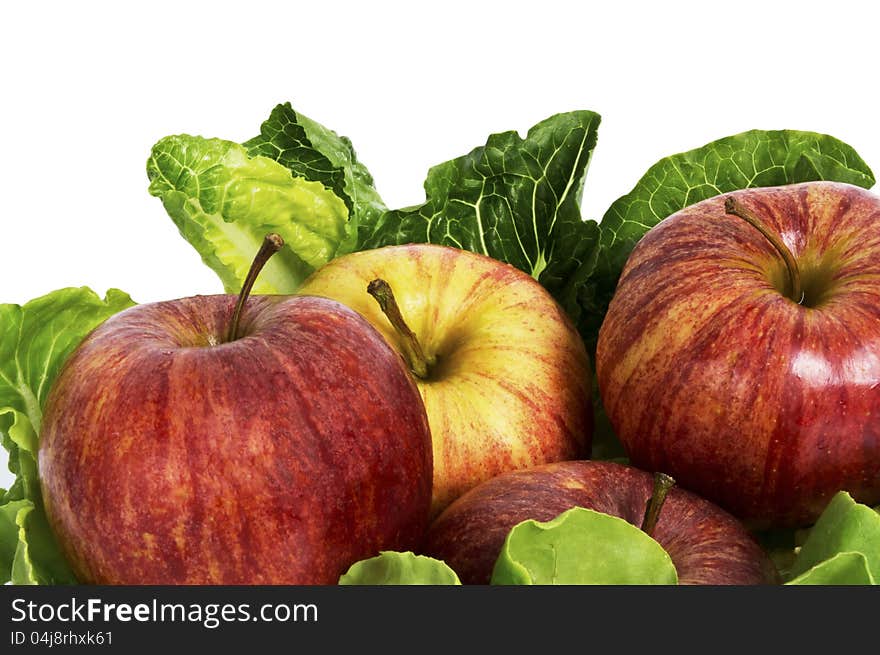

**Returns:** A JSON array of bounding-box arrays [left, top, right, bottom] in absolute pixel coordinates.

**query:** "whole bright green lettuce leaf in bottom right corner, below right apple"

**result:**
[[790, 491, 880, 584]]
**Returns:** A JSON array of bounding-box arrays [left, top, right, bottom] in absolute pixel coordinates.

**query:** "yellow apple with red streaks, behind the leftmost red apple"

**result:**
[[300, 244, 592, 514]]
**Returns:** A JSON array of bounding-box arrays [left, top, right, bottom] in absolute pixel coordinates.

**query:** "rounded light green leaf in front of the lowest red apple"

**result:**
[[492, 507, 678, 585]]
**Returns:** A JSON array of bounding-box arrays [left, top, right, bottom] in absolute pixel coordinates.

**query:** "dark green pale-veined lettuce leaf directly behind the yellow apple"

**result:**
[[358, 111, 599, 330]]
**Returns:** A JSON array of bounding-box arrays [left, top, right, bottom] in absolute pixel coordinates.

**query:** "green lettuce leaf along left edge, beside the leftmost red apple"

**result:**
[[0, 287, 134, 584]]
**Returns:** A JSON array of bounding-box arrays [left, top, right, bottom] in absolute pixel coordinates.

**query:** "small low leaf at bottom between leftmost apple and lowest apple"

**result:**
[[339, 550, 461, 585]]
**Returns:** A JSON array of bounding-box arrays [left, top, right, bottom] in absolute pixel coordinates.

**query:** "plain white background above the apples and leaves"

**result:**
[[0, 0, 880, 486]]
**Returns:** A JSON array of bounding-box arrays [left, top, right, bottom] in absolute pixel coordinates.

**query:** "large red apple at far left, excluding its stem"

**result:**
[[39, 296, 431, 584]]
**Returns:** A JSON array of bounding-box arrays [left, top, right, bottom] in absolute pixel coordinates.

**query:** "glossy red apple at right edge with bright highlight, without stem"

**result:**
[[596, 182, 880, 528]]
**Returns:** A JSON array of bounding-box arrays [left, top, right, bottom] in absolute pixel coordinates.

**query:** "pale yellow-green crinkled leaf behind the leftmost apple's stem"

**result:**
[[147, 135, 350, 294]]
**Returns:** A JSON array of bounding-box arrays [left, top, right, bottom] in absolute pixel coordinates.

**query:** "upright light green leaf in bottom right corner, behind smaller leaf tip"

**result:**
[[791, 491, 880, 584]]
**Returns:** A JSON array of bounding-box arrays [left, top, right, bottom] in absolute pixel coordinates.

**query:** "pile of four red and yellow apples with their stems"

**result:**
[[39, 182, 880, 584]]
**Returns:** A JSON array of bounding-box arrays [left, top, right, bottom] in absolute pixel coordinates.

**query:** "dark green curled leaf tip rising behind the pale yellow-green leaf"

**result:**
[[244, 102, 387, 254]]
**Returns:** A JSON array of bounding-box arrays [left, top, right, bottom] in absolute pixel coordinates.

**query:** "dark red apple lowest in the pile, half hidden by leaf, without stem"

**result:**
[[421, 461, 778, 585]]
